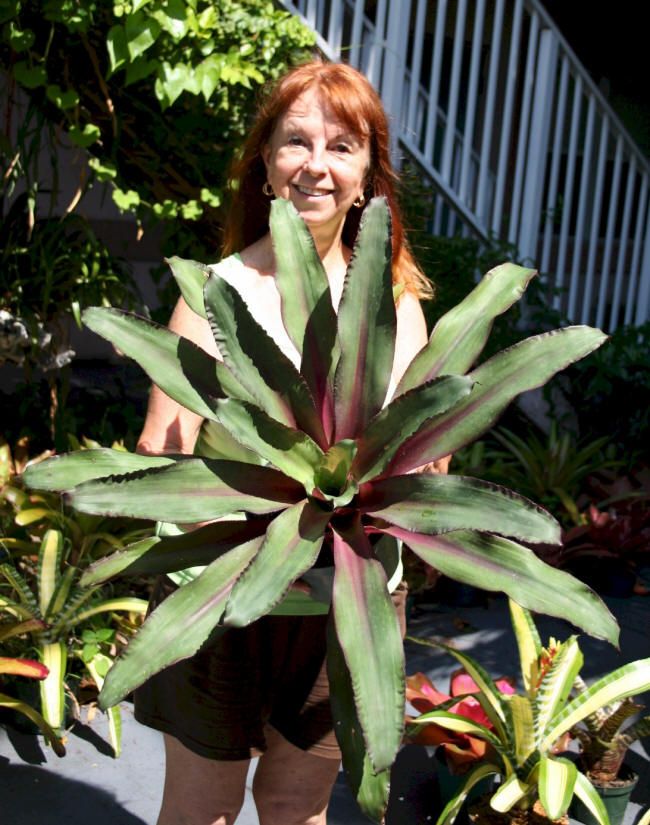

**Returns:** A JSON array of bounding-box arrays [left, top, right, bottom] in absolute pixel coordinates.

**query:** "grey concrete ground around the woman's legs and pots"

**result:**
[[0, 596, 650, 825]]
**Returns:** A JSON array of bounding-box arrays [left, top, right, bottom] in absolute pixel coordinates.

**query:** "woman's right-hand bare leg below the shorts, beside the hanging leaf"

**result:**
[[253, 725, 339, 825]]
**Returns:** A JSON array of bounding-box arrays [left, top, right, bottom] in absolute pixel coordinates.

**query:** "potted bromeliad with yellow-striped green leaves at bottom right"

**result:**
[[410, 600, 650, 825]]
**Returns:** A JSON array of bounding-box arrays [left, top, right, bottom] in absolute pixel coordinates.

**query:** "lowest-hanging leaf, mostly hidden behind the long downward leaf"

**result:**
[[327, 620, 390, 822]]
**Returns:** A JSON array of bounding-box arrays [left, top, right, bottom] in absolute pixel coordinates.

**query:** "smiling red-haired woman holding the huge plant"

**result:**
[[136, 62, 444, 825]]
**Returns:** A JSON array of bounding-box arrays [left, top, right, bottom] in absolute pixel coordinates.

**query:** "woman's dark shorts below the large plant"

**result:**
[[135, 576, 406, 761]]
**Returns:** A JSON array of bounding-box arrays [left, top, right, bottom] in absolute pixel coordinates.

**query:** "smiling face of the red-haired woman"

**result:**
[[262, 88, 370, 246]]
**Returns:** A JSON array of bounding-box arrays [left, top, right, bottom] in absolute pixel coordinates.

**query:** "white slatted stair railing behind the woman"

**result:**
[[283, 0, 650, 332]]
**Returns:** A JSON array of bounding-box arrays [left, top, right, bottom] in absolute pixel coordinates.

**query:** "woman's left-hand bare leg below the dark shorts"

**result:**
[[158, 734, 249, 825]]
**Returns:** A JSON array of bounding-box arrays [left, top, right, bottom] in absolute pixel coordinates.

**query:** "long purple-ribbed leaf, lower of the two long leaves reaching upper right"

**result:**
[[390, 327, 607, 473]]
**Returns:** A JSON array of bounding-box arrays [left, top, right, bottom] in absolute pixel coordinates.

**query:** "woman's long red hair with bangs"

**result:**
[[222, 61, 431, 297]]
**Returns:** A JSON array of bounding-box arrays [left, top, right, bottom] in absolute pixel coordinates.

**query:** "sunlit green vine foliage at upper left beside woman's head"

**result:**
[[0, 0, 313, 252]]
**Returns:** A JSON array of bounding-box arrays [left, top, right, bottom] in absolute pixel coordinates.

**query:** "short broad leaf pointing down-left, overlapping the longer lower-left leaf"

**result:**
[[224, 501, 331, 627]]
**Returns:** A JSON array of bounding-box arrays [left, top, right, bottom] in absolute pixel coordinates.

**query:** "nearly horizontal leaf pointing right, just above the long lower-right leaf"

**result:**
[[359, 473, 560, 544]]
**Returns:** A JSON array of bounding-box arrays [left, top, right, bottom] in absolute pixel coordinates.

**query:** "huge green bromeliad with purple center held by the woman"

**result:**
[[25, 199, 617, 820]]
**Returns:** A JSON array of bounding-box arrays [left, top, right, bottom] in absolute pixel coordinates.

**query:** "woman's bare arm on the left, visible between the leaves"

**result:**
[[136, 298, 219, 454]]
